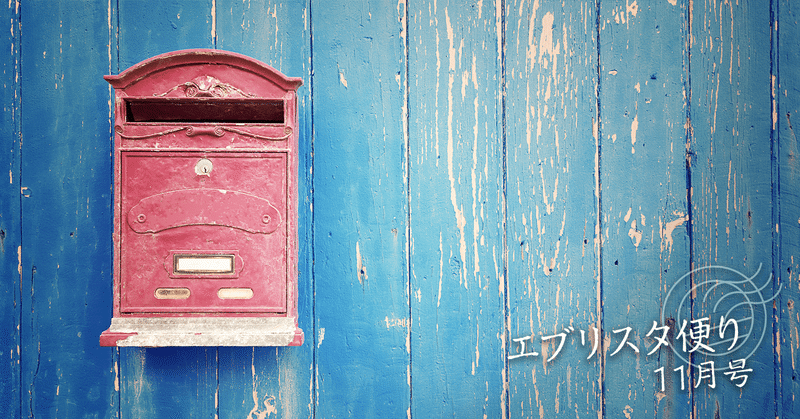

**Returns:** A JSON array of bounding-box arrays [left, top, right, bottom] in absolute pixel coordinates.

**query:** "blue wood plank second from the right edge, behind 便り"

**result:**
[[690, 1, 775, 418]]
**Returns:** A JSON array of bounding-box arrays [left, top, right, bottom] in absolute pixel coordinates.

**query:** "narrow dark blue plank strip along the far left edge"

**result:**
[[0, 4, 22, 417]]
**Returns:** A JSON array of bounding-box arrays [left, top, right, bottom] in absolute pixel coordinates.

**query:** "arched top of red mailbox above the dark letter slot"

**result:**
[[104, 49, 303, 96]]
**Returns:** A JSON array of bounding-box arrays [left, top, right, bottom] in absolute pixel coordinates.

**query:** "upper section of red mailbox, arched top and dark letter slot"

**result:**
[[105, 49, 302, 149]]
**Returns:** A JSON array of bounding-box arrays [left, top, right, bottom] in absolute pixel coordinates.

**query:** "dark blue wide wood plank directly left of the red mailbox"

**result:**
[[19, 1, 117, 417]]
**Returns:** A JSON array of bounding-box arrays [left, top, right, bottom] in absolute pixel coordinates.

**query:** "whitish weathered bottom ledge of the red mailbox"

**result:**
[[100, 317, 303, 347]]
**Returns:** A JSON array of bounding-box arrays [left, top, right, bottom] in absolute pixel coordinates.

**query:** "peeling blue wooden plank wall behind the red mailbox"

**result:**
[[0, 0, 800, 418]]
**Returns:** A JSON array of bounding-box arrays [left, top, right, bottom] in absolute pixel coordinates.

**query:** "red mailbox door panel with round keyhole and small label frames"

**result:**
[[118, 151, 290, 313]]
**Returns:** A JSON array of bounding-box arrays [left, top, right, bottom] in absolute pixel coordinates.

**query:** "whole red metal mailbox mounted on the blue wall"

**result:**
[[100, 50, 303, 347]]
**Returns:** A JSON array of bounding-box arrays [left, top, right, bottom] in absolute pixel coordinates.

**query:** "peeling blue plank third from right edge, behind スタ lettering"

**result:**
[[598, 2, 691, 418]]
